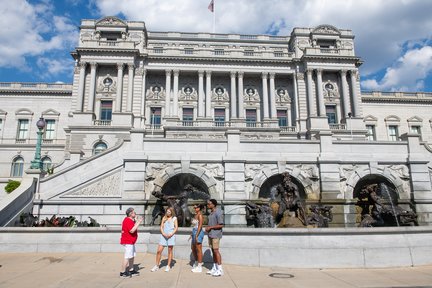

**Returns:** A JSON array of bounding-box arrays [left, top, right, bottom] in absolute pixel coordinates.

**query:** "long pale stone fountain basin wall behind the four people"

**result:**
[[0, 226, 432, 268]]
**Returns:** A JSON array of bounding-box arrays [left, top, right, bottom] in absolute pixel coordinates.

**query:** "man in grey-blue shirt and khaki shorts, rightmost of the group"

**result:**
[[205, 199, 224, 277]]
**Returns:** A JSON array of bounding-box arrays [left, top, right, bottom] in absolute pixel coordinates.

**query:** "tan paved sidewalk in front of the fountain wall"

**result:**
[[0, 252, 432, 288]]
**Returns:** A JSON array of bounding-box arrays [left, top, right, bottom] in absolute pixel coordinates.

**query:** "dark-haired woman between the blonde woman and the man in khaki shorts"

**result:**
[[191, 204, 204, 273]]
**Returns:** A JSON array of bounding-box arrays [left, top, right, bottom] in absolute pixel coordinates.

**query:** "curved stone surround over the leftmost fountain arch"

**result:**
[[154, 165, 219, 200]]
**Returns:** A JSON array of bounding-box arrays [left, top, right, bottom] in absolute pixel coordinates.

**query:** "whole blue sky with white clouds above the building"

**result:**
[[0, 0, 432, 92]]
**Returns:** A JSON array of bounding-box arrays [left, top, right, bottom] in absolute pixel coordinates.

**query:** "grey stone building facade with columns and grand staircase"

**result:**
[[0, 17, 432, 226]]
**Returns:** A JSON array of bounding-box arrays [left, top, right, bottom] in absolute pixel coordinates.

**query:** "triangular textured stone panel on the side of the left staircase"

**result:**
[[64, 173, 121, 197]]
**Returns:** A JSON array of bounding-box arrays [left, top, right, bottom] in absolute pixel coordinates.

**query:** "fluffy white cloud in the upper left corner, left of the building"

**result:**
[[0, 0, 78, 71]]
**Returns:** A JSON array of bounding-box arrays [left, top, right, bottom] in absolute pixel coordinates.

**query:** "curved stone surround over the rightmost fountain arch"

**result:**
[[345, 167, 405, 199]]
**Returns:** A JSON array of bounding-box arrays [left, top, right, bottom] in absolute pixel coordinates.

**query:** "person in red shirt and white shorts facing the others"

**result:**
[[120, 208, 143, 277]]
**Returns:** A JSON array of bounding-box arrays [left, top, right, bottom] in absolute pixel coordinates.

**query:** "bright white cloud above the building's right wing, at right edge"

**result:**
[[362, 46, 432, 91]]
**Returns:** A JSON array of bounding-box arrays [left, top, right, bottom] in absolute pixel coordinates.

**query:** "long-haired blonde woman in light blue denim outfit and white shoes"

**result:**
[[151, 207, 178, 272]]
